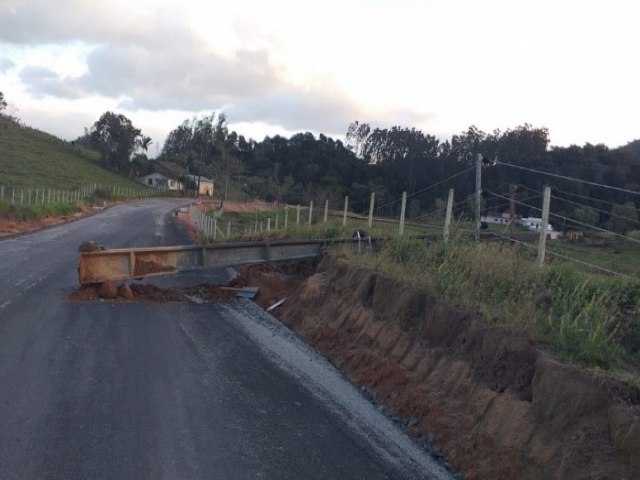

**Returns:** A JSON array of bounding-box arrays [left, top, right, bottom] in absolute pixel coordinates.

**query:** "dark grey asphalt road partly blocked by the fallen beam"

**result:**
[[0, 200, 449, 479]]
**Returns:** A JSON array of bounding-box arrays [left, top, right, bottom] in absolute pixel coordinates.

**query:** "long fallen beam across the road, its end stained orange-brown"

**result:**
[[78, 239, 368, 285]]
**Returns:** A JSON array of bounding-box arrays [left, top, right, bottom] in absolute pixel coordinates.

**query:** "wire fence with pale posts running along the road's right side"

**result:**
[[181, 158, 640, 277]]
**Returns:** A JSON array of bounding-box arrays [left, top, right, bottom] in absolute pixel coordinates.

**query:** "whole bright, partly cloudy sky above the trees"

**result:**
[[0, 0, 640, 155]]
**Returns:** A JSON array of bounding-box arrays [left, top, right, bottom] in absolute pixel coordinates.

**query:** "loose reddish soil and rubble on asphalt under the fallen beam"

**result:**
[[69, 281, 235, 302]]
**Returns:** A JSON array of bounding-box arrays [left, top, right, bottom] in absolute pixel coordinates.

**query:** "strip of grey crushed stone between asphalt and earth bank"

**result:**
[[225, 299, 453, 480]]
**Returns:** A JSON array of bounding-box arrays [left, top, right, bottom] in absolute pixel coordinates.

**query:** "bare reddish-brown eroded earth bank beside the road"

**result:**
[[279, 257, 640, 479]]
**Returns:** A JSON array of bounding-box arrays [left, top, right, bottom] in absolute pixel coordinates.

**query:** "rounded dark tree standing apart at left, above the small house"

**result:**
[[91, 112, 143, 173]]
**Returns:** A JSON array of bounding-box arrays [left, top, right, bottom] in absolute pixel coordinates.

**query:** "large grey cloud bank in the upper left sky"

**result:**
[[0, 0, 432, 141]]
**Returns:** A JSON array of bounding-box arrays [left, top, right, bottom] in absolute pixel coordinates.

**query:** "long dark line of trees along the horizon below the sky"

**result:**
[[77, 112, 640, 233]]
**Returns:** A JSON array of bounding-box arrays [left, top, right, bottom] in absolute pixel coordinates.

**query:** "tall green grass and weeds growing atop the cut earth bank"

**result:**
[[347, 234, 640, 368]]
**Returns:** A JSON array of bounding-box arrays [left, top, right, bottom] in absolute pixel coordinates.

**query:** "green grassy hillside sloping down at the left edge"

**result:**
[[0, 118, 140, 190]]
